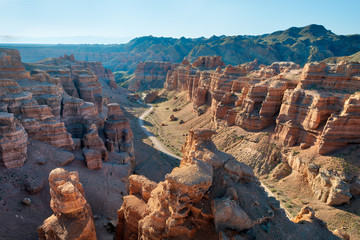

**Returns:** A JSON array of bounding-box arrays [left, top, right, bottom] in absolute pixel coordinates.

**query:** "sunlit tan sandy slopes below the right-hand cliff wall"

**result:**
[[142, 91, 360, 239]]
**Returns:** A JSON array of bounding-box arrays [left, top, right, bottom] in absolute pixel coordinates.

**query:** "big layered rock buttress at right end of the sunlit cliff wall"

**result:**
[[275, 62, 360, 154]]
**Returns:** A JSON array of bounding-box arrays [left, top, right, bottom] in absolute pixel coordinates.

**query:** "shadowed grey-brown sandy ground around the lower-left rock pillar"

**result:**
[[0, 141, 130, 239]]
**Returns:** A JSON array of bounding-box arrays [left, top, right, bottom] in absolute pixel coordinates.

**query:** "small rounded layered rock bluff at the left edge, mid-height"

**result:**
[[0, 112, 28, 168]]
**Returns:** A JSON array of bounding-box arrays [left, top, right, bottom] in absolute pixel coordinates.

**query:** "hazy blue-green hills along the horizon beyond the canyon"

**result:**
[[1, 25, 360, 72]]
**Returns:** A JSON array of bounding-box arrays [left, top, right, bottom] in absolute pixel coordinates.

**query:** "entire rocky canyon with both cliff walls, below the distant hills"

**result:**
[[0, 31, 360, 240]]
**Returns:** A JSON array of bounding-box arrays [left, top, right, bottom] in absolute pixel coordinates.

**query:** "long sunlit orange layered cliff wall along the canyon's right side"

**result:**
[[164, 57, 360, 154]]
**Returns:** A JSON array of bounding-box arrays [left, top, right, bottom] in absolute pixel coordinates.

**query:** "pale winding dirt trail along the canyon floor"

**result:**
[[138, 104, 292, 219]]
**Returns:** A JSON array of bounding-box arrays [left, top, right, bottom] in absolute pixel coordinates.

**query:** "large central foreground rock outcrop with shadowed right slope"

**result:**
[[116, 129, 336, 239]]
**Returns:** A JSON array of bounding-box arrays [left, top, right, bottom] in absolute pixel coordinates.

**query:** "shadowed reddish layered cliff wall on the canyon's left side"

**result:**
[[0, 49, 134, 169]]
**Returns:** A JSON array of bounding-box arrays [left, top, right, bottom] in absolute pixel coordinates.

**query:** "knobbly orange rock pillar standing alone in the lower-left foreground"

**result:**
[[38, 168, 97, 240]]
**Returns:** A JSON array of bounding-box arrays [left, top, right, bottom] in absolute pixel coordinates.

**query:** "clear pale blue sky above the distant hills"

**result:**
[[0, 0, 360, 43]]
